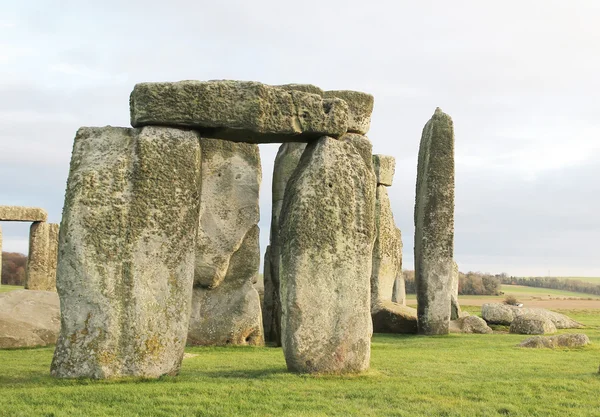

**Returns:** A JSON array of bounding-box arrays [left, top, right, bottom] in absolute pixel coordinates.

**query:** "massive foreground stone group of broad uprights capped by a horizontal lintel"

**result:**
[[51, 81, 380, 378]]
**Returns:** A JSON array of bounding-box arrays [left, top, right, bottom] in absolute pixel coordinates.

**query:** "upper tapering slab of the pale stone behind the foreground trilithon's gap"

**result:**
[[194, 138, 262, 288]]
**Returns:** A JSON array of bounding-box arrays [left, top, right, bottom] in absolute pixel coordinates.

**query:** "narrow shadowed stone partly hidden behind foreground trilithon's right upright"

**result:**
[[263, 142, 306, 346]]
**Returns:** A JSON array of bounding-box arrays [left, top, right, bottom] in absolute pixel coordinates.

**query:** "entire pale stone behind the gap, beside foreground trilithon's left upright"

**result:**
[[188, 138, 264, 345]]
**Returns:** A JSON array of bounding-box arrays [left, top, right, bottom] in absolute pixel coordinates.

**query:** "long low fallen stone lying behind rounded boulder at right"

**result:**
[[481, 303, 582, 329]]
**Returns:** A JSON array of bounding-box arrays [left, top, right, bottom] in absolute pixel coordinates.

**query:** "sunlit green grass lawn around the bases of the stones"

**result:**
[[0, 307, 600, 417]]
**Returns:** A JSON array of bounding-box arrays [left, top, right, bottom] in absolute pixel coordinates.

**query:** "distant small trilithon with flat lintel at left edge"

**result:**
[[0, 206, 59, 291]]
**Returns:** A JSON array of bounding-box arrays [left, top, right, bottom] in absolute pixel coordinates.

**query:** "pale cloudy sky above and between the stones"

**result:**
[[0, 0, 600, 276]]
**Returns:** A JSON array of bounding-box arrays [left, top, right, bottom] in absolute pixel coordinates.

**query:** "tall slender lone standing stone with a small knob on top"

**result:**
[[415, 108, 454, 335]]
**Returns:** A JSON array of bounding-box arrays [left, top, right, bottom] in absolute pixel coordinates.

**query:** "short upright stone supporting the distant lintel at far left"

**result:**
[[25, 222, 59, 291]]
